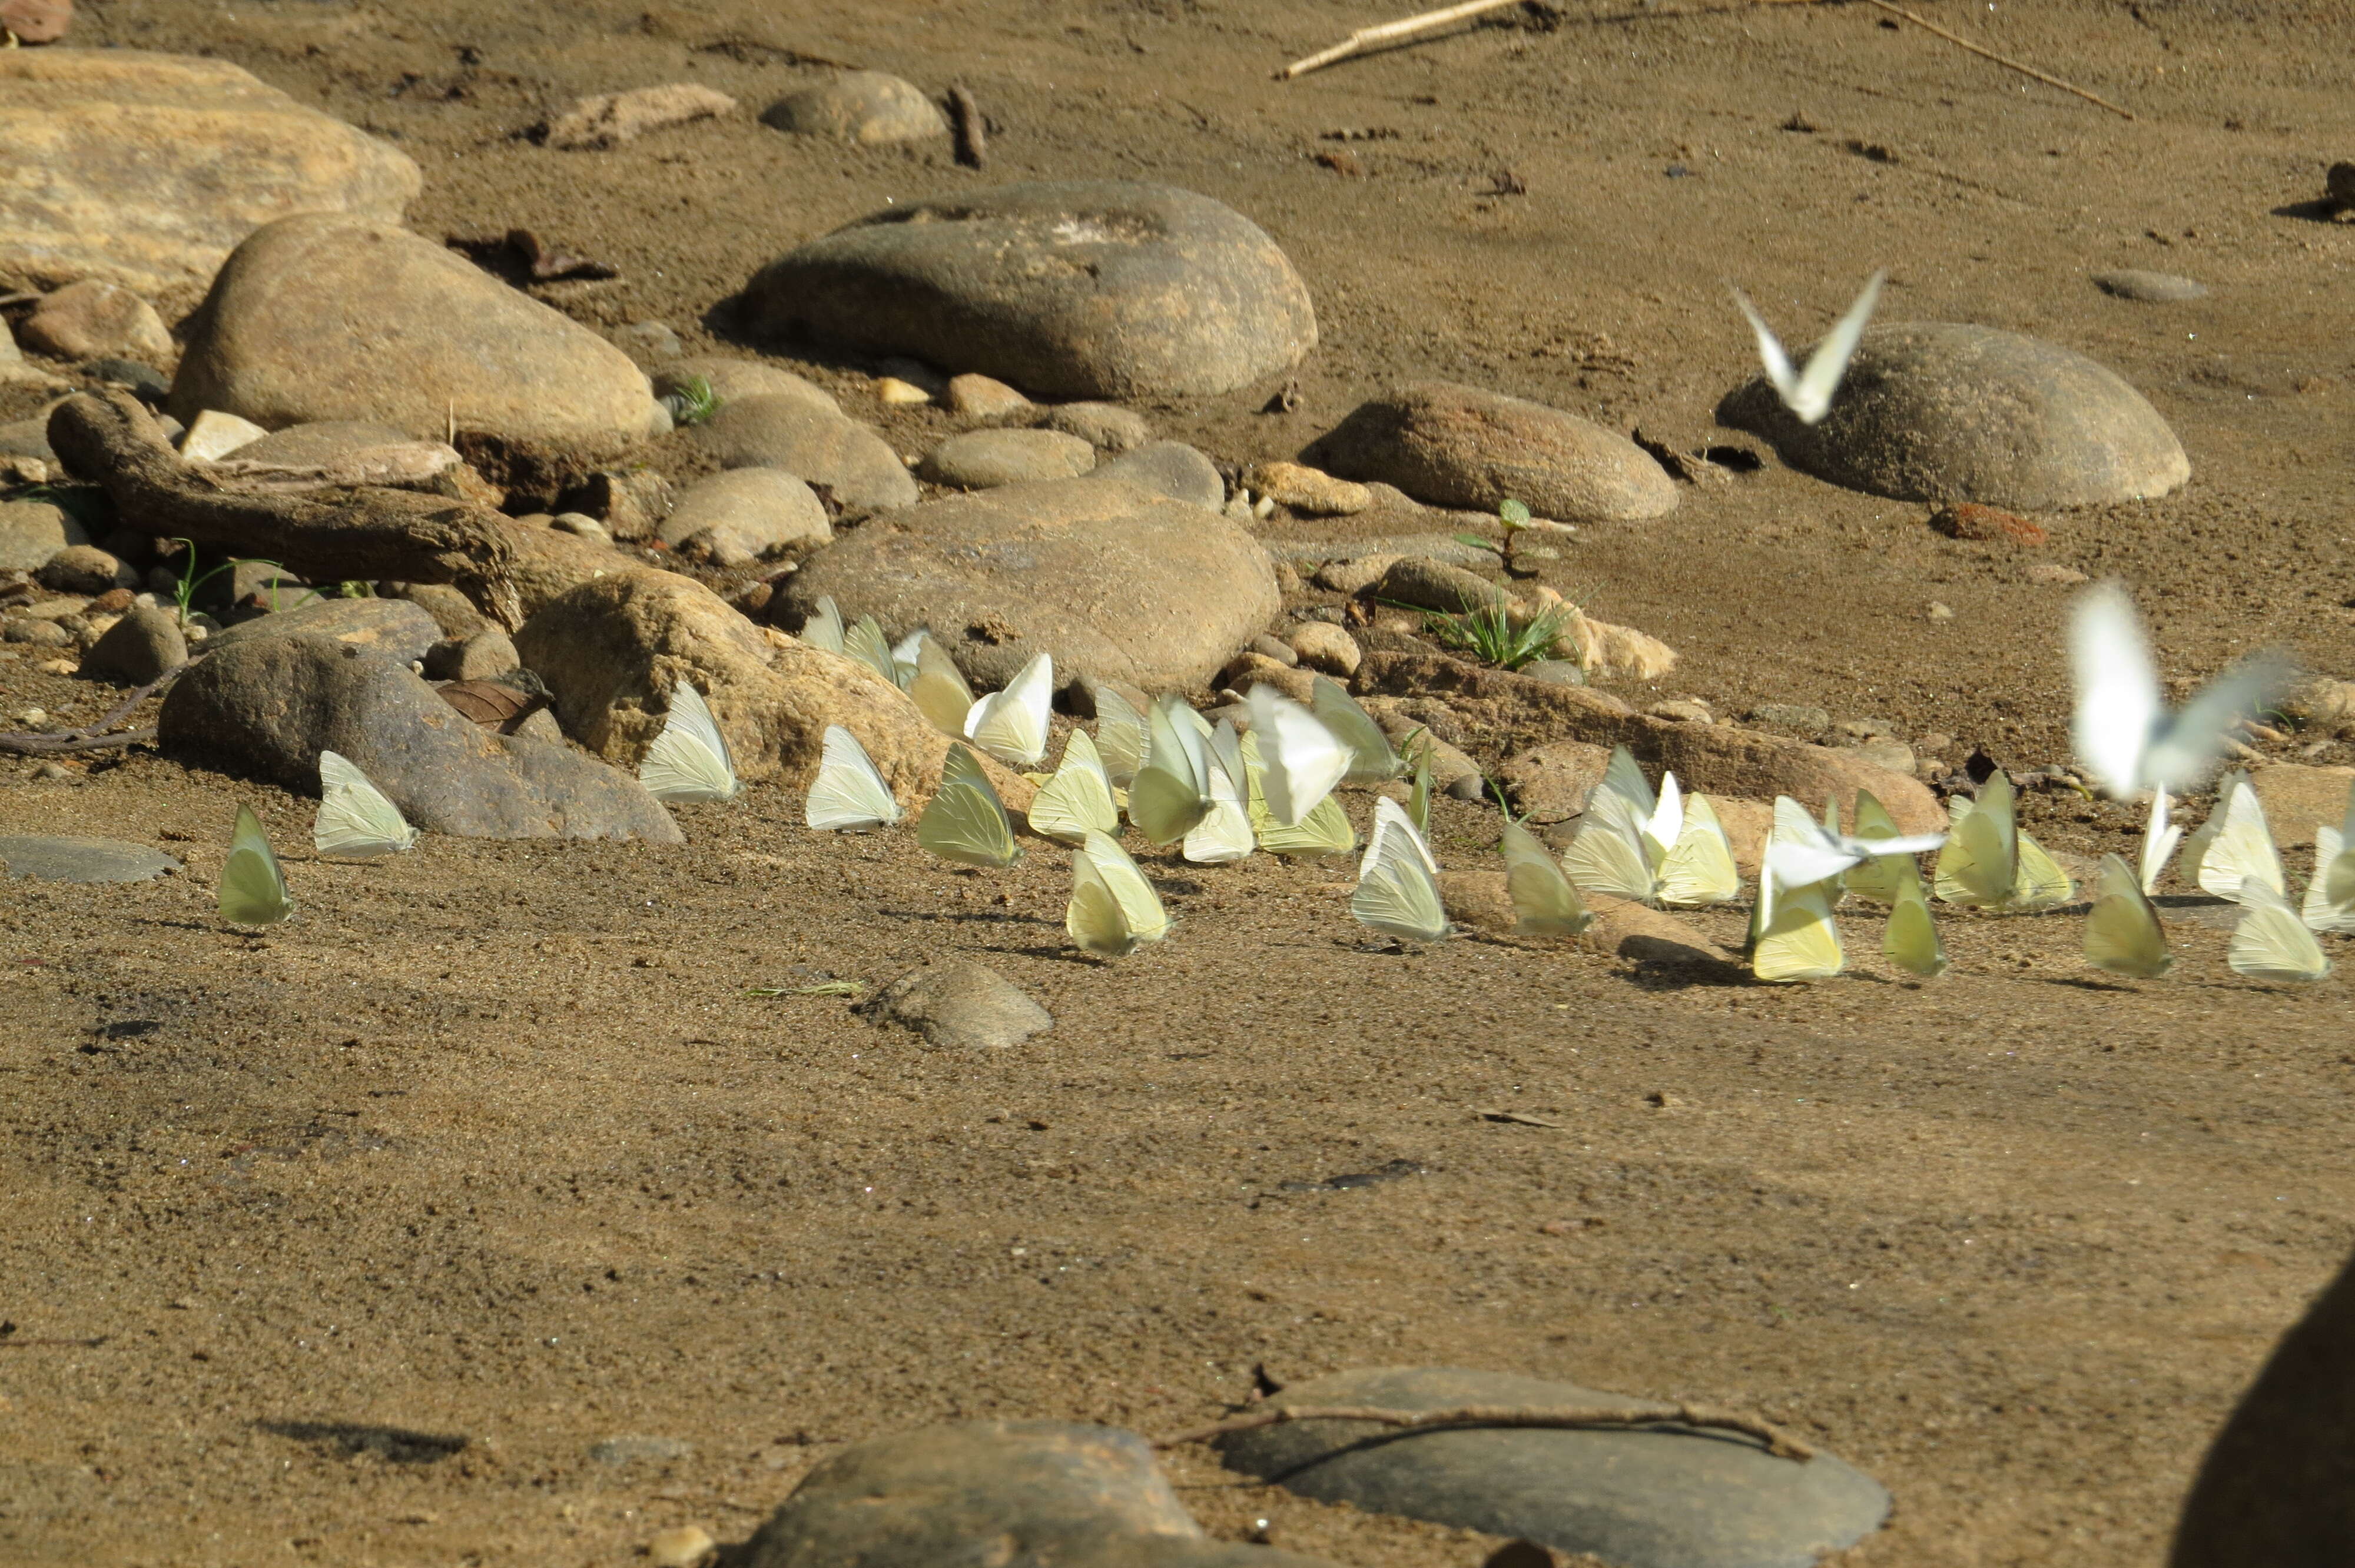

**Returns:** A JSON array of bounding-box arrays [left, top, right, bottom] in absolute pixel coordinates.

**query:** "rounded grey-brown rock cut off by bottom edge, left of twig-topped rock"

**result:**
[[742, 1422, 1338, 1568]]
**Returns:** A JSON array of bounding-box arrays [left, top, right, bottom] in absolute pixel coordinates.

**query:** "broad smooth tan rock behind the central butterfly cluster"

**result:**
[[784, 478, 1281, 692]]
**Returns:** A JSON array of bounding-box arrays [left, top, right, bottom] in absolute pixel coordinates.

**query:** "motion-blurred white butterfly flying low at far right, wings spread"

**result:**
[[2068, 582, 2287, 796]]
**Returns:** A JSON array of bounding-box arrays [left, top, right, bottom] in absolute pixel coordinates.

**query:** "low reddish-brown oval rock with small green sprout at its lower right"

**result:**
[[1300, 381, 1677, 523]]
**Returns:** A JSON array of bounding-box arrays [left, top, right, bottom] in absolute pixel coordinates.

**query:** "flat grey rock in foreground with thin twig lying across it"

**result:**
[[1220, 1368, 1889, 1568]]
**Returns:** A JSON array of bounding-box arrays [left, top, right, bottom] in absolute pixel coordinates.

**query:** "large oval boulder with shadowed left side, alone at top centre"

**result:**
[[744, 179, 1316, 398]]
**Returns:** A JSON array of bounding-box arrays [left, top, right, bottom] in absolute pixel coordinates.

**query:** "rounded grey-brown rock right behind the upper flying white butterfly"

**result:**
[[1717, 323, 2193, 511]]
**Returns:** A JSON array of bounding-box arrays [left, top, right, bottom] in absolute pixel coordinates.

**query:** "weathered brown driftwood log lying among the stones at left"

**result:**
[[49, 391, 523, 629]]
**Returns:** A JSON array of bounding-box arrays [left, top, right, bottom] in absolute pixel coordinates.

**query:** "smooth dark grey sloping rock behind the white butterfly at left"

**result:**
[[158, 631, 681, 843]]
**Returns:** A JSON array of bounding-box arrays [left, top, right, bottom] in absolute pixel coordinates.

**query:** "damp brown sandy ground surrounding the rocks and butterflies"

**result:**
[[0, 0, 2355, 1568]]
